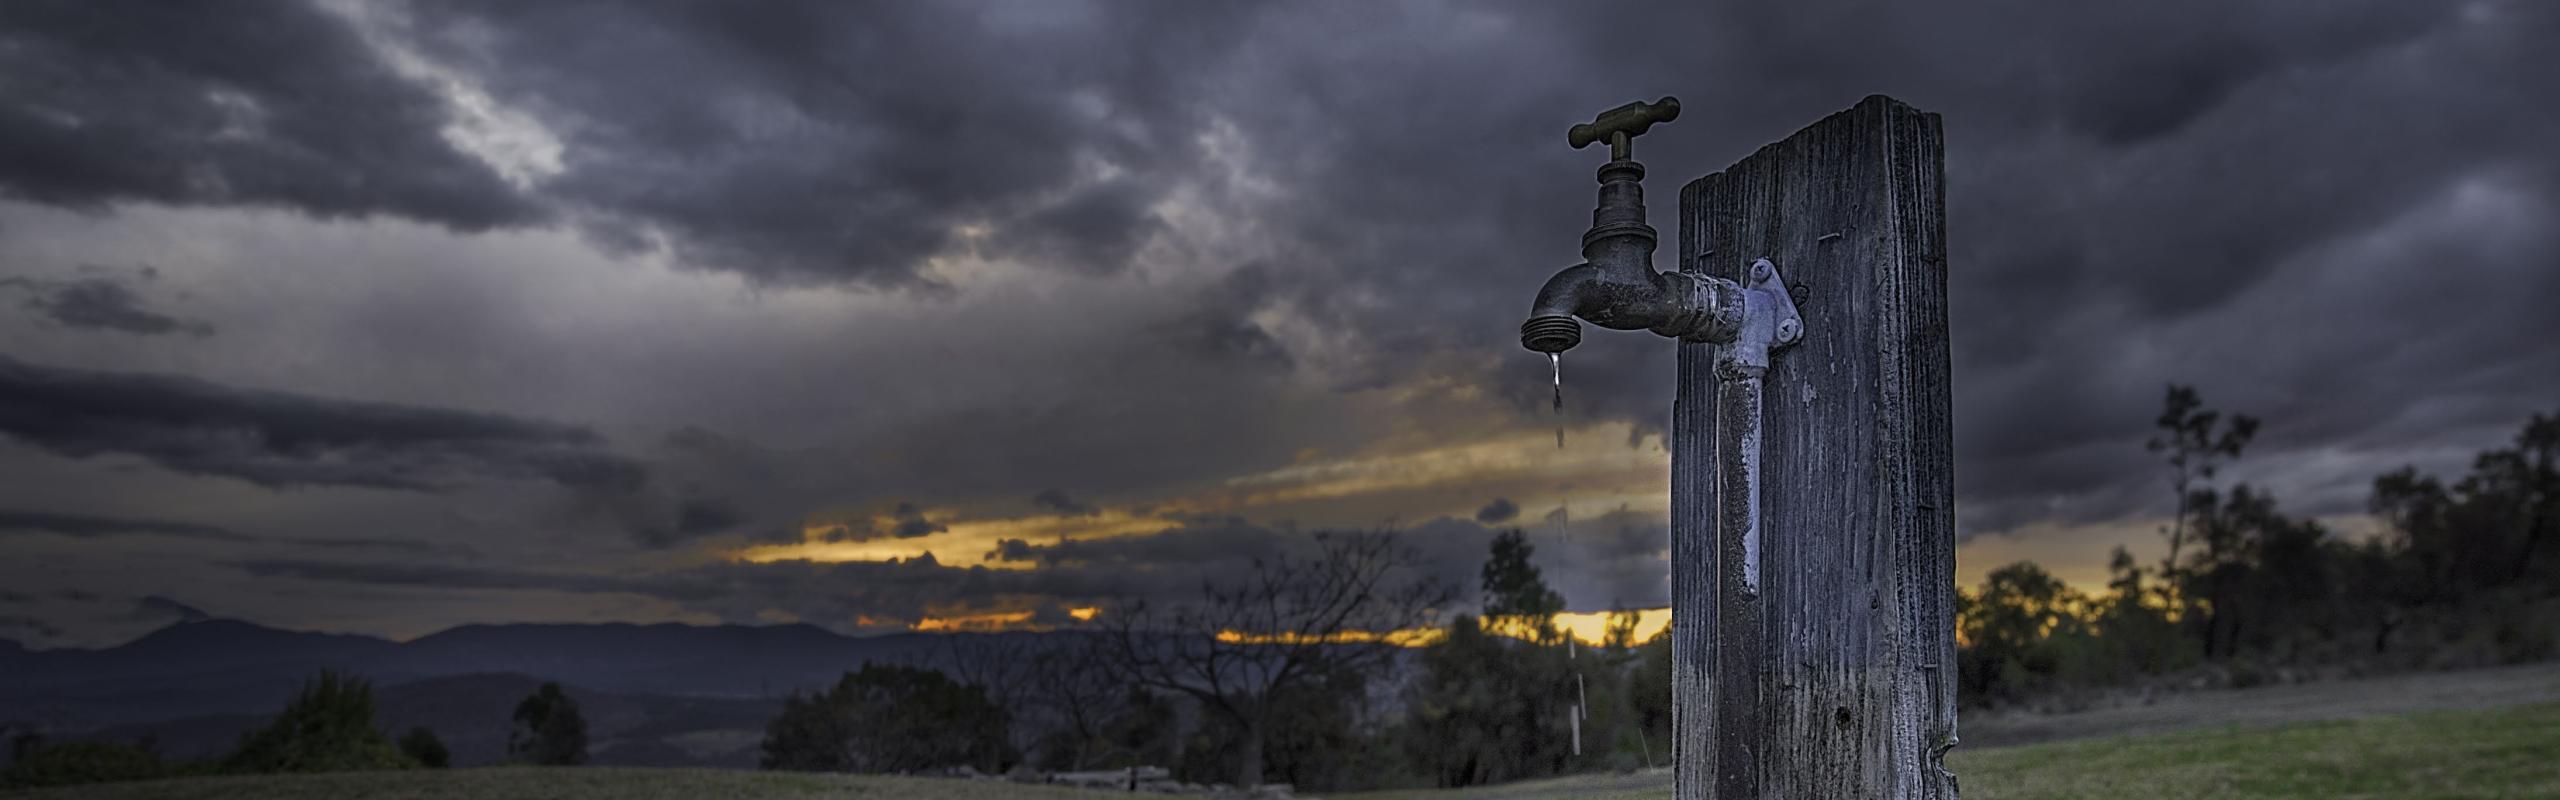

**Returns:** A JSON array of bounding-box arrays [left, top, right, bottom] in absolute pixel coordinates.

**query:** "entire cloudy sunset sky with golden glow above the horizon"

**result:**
[[0, 0, 2560, 646]]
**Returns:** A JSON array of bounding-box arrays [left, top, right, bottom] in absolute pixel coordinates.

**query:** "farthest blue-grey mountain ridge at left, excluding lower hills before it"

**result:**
[[0, 618, 1047, 738]]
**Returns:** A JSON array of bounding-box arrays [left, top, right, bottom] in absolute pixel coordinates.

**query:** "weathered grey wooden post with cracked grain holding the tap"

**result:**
[[1672, 95, 1956, 800]]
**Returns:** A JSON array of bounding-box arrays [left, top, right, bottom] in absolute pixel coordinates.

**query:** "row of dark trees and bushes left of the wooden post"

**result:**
[[763, 531, 1672, 790]]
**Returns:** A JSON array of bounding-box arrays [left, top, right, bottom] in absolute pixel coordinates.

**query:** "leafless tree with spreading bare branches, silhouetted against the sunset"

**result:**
[[1101, 533, 1452, 787]]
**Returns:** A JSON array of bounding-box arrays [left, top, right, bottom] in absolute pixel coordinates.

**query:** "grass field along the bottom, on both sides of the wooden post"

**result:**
[[24, 703, 2560, 800]]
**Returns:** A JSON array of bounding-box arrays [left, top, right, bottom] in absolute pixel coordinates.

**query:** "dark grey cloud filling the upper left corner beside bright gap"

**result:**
[[0, 0, 538, 231]]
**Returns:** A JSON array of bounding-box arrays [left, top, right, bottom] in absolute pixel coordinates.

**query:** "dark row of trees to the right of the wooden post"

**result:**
[[1956, 385, 2560, 708]]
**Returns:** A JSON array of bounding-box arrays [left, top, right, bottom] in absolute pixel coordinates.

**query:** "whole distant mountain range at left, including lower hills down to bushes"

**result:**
[[0, 621, 1055, 767]]
